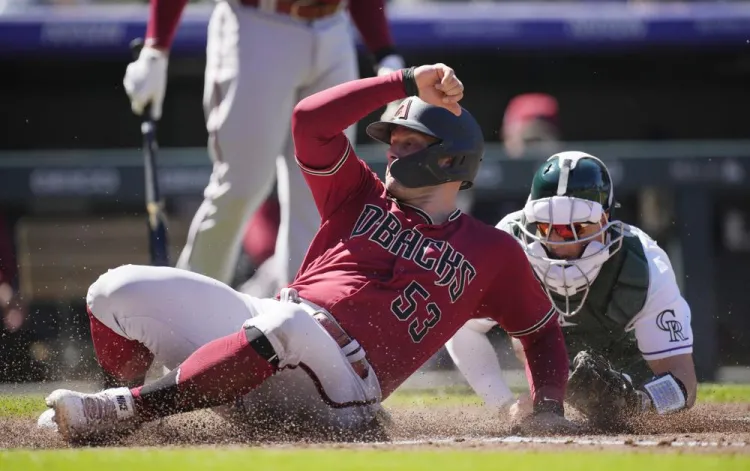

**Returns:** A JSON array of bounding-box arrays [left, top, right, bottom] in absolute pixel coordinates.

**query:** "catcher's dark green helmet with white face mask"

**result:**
[[514, 151, 624, 316]]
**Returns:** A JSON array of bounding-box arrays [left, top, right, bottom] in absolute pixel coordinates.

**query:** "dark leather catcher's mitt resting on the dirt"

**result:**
[[566, 352, 643, 429]]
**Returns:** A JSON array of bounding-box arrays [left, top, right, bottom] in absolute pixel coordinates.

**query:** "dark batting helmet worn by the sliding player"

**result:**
[[367, 97, 484, 190]]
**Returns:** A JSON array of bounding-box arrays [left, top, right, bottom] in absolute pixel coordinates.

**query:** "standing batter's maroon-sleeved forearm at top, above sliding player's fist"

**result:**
[[349, 0, 396, 62]]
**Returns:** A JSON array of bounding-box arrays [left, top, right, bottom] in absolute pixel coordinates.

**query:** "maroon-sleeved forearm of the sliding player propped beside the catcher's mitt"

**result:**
[[520, 321, 568, 404]]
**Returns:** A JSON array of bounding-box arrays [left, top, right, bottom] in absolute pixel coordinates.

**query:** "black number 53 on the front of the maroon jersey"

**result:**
[[391, 281, 440, 343]]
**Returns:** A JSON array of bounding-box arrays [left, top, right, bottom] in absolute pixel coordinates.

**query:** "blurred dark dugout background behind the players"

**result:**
[[0, 0, 750, 390]]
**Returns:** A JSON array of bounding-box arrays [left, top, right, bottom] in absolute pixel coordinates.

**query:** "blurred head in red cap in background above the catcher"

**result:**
[[500, 93, 560, 158]]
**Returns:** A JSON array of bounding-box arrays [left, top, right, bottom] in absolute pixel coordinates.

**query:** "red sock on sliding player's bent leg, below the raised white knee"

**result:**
[[86, 308, 154, 384]]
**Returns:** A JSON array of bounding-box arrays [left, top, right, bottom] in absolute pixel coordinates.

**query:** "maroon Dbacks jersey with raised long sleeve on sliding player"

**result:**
[[291, 73, 554, 397]]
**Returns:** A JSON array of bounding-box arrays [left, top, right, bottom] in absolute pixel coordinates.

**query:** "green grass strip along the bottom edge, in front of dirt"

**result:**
[[0, 448, 750, 471]]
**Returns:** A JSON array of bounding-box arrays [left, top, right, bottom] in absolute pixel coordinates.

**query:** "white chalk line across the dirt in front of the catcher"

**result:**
[[382, 436, 748, 448]]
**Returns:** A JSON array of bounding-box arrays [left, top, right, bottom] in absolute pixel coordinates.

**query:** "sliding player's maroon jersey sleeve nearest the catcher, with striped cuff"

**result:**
[[477, 236, 556, 338]]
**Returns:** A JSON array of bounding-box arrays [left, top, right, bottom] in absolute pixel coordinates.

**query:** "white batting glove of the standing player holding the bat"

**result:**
[[122, 46, 167, 120]]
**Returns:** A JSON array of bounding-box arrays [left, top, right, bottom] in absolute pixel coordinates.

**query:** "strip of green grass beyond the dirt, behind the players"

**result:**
[[0, 384, 750, 418]]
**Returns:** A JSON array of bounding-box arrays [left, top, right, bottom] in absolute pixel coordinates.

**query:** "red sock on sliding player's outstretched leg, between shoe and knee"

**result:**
[[131, 329, 278, 420]]
